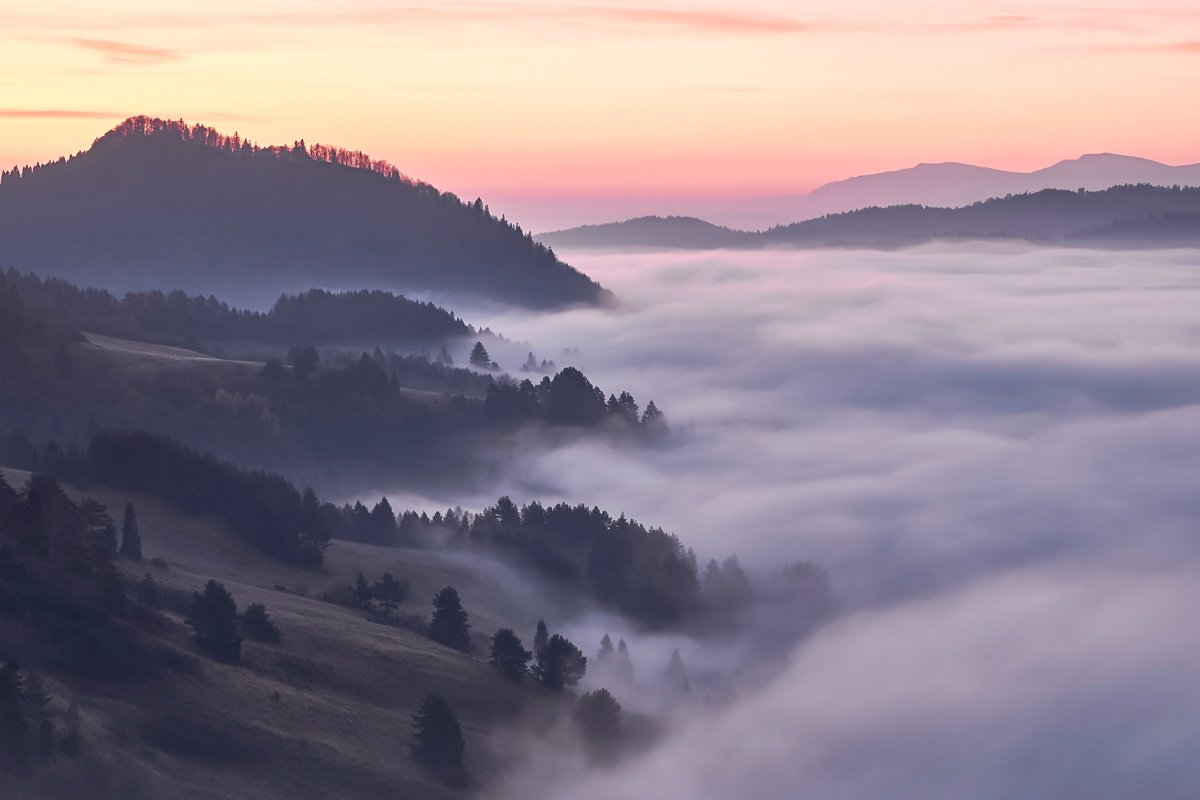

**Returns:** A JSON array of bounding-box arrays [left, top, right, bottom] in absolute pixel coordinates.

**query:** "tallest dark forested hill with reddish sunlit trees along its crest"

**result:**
[[0, 118, 608, 307]]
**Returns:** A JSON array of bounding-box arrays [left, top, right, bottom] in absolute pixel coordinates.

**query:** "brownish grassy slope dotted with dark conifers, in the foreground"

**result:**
[[4, 470, 566, 800]]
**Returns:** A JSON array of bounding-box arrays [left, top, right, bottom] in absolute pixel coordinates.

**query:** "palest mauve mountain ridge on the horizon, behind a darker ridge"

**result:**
[[749, 152, 1200, 224]]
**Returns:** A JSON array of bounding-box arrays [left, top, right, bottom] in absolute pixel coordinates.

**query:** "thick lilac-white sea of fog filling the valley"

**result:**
[[410, 245, 1200, 800]]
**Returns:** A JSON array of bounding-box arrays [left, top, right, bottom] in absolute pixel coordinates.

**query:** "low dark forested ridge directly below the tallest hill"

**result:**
[[5, 270, 478, 345]]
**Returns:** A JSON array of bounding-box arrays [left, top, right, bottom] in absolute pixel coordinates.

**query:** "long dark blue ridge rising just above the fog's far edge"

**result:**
[[538, 185, 1200, 249]]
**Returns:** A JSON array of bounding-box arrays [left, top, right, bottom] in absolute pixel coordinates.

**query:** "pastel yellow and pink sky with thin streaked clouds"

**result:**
[[0, 0, 1200, 230]]
